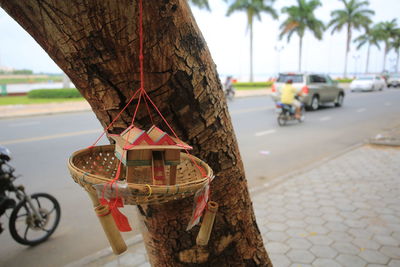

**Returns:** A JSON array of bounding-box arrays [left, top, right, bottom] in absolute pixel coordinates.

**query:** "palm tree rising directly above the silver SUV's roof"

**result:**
[[280, 0, 325, 71]]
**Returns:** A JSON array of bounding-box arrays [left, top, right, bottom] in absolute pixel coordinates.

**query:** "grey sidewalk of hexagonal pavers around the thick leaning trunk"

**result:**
[[65, 126, 400, 267]]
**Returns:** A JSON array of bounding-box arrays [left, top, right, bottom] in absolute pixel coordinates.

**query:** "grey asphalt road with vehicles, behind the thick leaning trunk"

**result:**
[[0, 89, 400, 266]]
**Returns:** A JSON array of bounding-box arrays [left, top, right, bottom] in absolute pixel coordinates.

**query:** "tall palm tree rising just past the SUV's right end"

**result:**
[[328, 0, 375, 77]]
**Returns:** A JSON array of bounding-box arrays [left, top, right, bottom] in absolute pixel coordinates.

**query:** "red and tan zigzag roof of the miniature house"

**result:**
[[108, 125, 192, 150]]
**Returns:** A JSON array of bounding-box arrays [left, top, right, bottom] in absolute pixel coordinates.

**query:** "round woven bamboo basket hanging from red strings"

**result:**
[[68, 145, 213, 205]]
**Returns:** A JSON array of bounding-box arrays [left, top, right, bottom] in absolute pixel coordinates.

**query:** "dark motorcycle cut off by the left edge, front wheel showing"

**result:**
[[0, 146, 61, 246]]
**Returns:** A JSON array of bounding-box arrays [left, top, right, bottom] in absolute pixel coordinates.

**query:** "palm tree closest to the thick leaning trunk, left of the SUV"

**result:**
[[225, 0, 278, 82]]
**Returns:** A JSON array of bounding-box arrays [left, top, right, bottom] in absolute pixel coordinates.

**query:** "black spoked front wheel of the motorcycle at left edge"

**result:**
[[9, 193, 61, 246]]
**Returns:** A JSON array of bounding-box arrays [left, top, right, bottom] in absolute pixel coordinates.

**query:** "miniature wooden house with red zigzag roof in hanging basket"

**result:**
[[109, 126, 192, 185]]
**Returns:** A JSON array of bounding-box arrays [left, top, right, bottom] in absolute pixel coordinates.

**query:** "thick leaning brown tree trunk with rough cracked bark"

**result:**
[[0, 0, 272, 266]]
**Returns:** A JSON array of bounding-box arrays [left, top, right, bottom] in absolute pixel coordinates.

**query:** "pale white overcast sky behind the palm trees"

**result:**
[[0, 0, 400, 81]]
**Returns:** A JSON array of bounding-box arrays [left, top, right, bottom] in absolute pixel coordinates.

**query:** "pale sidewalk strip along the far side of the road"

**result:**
[[0, 89, 271, 119]]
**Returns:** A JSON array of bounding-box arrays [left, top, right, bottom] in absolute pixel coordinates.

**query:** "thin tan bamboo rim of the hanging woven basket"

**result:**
[[68, 144, 214, 195]]
